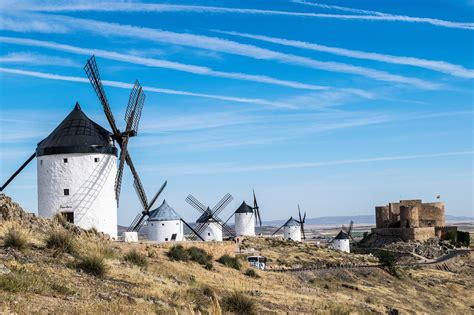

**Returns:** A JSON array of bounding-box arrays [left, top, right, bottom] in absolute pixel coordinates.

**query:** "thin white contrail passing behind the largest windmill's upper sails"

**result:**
[[0, 67, 295, 108]]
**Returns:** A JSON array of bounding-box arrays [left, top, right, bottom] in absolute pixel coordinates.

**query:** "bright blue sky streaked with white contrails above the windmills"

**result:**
[[0, 0, 474, 225]]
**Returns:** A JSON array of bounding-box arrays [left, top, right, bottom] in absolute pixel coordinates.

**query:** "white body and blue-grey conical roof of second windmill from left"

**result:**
[[147, 200, 184, 242]]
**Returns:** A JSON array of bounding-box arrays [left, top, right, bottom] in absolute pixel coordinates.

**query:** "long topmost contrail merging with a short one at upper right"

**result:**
[[2, 0, 474, 30]]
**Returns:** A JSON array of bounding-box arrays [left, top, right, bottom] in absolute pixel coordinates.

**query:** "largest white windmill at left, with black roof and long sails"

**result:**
[[0, 56, 156, 239]]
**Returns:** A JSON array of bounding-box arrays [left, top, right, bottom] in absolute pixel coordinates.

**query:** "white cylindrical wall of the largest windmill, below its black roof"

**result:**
[[37, 153, 117, 239]]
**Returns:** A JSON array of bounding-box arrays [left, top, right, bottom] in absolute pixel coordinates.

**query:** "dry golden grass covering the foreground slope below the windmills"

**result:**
[[0, 232, 474, 314]]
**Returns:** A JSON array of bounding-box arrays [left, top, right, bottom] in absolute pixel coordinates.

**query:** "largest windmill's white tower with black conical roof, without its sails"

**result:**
[[36, 103, 117, 239]]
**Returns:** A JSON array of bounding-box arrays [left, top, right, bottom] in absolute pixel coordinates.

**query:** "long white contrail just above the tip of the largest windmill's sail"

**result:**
[[0, 37, 338, 90]]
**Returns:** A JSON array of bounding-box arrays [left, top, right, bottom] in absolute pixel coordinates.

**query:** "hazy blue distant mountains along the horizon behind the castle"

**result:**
[[263, 214, 474, 226]]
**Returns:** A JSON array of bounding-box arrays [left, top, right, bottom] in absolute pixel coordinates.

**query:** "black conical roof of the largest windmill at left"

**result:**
[[36, 103, 117, 156]]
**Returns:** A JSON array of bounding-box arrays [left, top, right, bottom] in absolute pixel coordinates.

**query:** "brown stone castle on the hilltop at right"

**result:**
[[372, 200, 456, 241]]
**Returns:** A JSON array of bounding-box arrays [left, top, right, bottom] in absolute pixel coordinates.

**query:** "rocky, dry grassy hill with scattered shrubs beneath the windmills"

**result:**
[[0, 196, 474, 314]]
